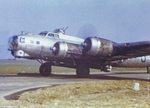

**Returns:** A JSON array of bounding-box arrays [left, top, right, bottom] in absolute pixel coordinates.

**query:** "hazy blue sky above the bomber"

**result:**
[[0, 0, 150, 59]]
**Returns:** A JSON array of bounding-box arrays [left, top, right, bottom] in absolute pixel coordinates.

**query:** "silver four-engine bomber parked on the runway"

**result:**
[[8, 29, 150, 78]]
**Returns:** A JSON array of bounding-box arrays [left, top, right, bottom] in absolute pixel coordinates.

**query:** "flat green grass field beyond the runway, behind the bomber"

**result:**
[[0, 60, 146, 74]]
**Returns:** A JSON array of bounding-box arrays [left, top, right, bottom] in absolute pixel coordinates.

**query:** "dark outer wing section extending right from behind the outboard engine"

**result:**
[[112, 41, 150, 59]]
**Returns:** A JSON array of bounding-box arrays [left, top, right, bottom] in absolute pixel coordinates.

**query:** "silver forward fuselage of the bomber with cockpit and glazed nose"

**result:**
[[9, 31, 84, 60]]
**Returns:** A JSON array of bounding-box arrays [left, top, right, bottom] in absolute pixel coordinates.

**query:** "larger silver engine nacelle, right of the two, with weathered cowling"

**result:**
[[82, 37, 113, 56]]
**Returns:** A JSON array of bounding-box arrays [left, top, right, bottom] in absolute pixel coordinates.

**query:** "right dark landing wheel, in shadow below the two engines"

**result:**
[[76, 64, 90, 78]]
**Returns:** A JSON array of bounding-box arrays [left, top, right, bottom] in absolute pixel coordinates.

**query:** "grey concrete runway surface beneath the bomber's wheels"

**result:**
[[0, 72, 150, 98]]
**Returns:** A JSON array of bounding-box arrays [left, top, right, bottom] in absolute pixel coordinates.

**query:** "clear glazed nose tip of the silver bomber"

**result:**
[[8, 36, 18, 51]]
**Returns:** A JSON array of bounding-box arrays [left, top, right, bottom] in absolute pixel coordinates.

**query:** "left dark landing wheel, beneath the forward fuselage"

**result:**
[[39, 62, 51, 76]]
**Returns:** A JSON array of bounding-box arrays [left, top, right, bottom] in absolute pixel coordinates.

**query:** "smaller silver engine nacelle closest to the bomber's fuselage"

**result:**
[[51, 42, 82, 58]]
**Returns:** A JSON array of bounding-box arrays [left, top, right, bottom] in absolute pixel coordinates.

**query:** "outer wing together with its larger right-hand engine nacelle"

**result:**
[[82, 37, 150, 60]]
